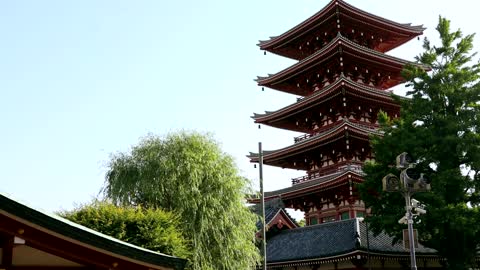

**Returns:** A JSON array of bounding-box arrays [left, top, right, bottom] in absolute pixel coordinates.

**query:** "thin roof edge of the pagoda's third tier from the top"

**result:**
[[252, 74, 400, 123]]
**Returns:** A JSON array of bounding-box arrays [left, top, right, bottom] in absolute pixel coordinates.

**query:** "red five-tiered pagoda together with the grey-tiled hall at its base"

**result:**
[[249, 0, 441, 269]]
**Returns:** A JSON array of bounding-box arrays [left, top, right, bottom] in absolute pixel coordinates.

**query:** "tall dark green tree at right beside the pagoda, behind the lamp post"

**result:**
[[361, 17, 480, 269]]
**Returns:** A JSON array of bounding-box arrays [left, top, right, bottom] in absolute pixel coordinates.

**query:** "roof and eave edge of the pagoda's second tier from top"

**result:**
[[256, 34, 428, 95]]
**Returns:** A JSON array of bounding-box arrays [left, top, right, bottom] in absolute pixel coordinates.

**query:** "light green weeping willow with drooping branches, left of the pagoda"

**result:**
[[104, 132, 259, 270]]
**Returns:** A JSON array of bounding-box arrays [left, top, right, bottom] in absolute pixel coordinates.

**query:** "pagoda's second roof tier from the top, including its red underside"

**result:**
[[256, 34, 428, 96]]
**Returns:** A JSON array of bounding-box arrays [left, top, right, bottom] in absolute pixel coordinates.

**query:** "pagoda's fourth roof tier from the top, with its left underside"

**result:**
[[248, 118, 381, 170]]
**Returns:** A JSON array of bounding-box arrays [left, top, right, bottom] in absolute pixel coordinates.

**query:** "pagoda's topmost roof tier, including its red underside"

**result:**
[[258, 0, 425, 60]]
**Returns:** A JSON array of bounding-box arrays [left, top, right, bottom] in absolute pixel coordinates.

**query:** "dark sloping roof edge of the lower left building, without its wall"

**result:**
[[0, 194, 186, 269]]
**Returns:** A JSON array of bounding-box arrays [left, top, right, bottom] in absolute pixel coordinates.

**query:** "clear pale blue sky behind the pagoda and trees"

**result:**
[[0, 0, 480, 211]]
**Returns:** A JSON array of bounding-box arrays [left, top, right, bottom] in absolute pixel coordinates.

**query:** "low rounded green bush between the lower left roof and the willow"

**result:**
[[60, 201, 191, 258]]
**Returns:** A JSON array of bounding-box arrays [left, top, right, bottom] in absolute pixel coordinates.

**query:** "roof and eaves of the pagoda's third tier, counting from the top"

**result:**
[[252, 74, 399, 132]]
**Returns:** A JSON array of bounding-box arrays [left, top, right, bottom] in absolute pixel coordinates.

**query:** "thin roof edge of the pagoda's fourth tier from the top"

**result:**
[[248, 118, 381, 165]]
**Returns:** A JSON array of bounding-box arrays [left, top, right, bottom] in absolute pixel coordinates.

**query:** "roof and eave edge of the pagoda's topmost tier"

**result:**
[[258, 0, 425, 57]]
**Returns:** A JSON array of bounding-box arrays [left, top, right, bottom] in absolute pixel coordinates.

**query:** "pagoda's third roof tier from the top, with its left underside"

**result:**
[[252, 74, 400, 133]]
